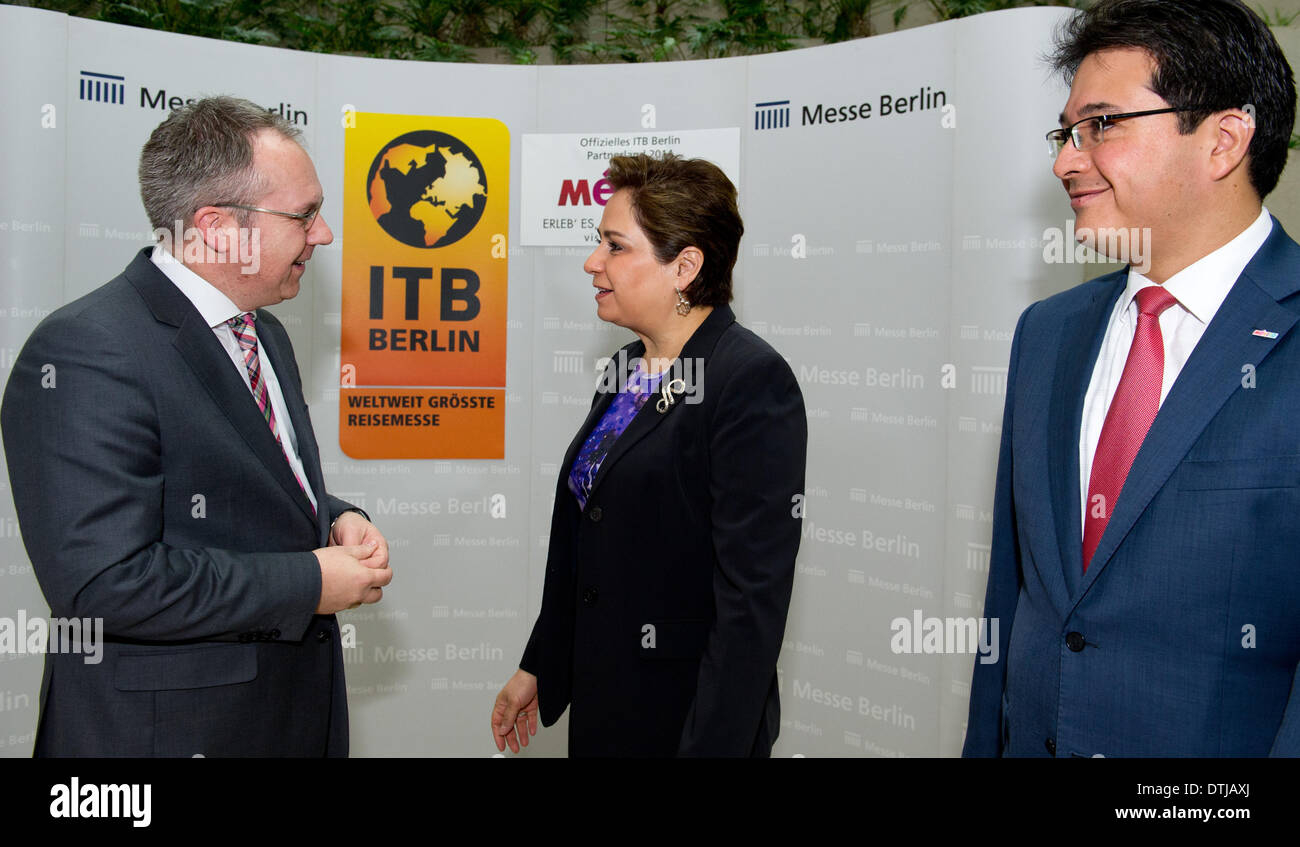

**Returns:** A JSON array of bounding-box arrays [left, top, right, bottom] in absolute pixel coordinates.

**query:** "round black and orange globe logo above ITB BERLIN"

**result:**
[[365, 130, 488, 247]]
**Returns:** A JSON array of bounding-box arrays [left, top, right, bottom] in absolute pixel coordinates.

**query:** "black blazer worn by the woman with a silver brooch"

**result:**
[[520, 305, 807, 756]]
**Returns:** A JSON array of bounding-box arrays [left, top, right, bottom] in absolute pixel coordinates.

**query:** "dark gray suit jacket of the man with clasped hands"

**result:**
[[0, 248, 348, 756]]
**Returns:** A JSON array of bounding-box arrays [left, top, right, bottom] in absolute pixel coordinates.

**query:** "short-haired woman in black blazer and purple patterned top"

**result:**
[[491, 155, 807, 756]]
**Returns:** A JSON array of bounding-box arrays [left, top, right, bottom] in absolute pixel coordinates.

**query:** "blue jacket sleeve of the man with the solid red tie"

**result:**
[[962, 307, 1034, 757]]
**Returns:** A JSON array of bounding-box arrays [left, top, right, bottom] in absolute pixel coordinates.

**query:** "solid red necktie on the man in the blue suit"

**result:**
[[1083, 286, 1178, 572]]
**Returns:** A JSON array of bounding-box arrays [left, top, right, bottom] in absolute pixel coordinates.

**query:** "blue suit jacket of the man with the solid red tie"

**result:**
[[963, 220, 1300, 756]]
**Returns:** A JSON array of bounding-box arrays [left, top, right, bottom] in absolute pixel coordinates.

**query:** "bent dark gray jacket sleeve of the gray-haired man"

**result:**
[[0, 314, 321, 640]]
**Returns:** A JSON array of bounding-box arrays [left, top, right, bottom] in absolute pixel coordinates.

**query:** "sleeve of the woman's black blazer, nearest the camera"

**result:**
[[679, 355, 807, 756]]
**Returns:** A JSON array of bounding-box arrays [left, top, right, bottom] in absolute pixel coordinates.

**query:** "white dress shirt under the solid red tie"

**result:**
[[1079, 209, 1273, 527]]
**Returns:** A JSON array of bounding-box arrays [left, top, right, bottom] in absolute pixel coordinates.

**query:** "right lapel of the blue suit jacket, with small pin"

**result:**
[[1083, 220, 1300, 591]]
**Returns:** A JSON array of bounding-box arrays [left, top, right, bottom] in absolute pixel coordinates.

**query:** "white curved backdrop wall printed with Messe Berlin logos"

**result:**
[[0, 6, 1100, 756]]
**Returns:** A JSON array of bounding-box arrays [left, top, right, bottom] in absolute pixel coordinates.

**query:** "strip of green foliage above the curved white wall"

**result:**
[[18, 0, 1087, 64]]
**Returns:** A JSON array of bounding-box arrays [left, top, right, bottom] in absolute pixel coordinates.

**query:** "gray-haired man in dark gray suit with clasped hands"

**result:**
[[0, 97, 393, 756]]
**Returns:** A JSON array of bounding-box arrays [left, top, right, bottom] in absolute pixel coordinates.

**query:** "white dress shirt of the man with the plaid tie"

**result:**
[[150, 246, 316, 508]]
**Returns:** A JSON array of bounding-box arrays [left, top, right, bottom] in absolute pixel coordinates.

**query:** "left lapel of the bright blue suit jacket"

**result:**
[[1045, 270, 1127, 599]]
